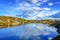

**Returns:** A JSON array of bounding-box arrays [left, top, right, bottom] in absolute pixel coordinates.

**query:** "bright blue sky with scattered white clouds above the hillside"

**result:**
[[0, 0, 60, 19]]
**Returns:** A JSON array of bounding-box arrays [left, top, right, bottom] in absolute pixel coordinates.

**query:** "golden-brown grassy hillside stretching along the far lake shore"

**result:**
[[0, 16, 56, 28]]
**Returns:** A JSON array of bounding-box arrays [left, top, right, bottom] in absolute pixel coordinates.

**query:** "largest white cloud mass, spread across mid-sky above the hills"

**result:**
[[15, 3, 59, 19]]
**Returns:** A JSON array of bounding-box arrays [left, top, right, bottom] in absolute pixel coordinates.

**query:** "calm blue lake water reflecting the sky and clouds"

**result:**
[[0, 24, 58, 40]]
